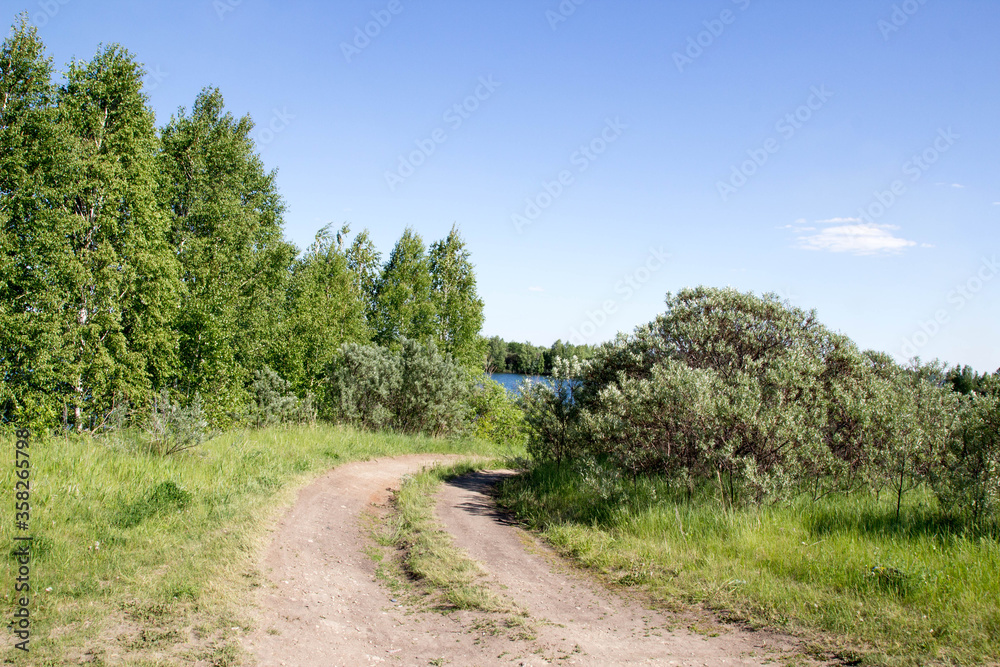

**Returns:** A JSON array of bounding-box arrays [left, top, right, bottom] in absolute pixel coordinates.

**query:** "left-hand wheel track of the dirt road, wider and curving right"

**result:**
[[243, 454, 544, 667]]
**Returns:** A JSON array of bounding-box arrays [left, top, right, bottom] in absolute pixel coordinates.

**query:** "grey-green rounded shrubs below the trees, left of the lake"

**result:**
[[323, 338, 470, 435]]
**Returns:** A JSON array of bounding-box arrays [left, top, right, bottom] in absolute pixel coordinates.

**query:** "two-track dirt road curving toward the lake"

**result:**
[[245, 455, 824, 667]]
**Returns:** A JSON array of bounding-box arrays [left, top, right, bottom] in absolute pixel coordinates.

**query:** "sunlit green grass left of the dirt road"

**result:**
[[0, 426, 508, 665]]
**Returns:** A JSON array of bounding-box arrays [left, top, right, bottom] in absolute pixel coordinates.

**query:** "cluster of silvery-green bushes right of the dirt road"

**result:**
[[521, 287, 1000, 521]]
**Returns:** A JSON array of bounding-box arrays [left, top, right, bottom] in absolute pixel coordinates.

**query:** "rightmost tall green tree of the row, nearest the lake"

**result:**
[[429, 227, 486, 370]]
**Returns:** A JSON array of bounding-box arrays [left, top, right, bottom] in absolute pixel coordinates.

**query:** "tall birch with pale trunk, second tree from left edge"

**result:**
[[57, 45, 179, 428]]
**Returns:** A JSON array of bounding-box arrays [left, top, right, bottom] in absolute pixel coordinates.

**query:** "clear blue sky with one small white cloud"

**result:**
[[15, 0, 1000, 371]]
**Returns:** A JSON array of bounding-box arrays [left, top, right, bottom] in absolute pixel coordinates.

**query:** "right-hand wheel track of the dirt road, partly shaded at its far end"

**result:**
[[437, 472, 820, 666]]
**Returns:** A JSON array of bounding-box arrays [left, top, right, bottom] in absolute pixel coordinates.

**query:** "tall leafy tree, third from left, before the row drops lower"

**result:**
[[162, 89, 295, 422]]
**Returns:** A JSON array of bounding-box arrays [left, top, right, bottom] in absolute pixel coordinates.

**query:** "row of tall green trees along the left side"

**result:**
[[0, 14, 486, 430]]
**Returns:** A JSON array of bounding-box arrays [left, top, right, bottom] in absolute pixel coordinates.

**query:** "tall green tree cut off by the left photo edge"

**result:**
[[0, 14, 66, 422]]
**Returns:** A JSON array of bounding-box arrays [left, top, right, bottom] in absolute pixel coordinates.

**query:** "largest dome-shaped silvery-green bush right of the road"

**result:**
[[580, 288, 861, 505]]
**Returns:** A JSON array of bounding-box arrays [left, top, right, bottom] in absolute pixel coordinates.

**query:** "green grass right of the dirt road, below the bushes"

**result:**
[[500, 467, 1000, 665]]
